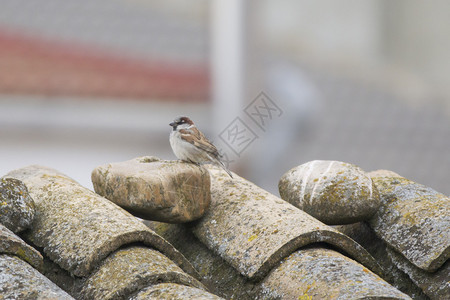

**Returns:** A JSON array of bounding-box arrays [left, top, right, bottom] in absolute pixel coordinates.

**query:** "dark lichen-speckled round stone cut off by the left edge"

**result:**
[[0, 178, 35, 233]]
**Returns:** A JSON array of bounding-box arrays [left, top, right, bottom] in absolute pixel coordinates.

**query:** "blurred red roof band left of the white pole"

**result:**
[[0, 29, 209, 101]]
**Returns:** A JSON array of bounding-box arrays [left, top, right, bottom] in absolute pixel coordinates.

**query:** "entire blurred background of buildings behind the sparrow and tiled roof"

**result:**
[[0, 0, 450, 195]]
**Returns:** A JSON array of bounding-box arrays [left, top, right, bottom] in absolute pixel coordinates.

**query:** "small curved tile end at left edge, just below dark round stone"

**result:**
[[0, 224, 43, 270]]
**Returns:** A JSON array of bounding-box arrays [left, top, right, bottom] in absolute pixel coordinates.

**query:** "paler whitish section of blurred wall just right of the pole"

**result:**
[[258, 0, 382, 62]]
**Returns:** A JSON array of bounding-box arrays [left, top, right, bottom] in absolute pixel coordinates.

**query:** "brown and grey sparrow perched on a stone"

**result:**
[[169, 117, 233, 178]]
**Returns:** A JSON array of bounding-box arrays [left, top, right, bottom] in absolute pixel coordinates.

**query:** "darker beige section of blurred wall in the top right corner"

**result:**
[[382, 0, 450, 97]]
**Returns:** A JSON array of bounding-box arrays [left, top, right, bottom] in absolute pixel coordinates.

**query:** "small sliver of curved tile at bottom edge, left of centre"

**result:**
[[129, 283, 223, 300]]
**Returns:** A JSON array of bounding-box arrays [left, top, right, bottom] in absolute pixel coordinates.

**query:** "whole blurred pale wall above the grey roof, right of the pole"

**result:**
[[255, 0, 450, 106]]
